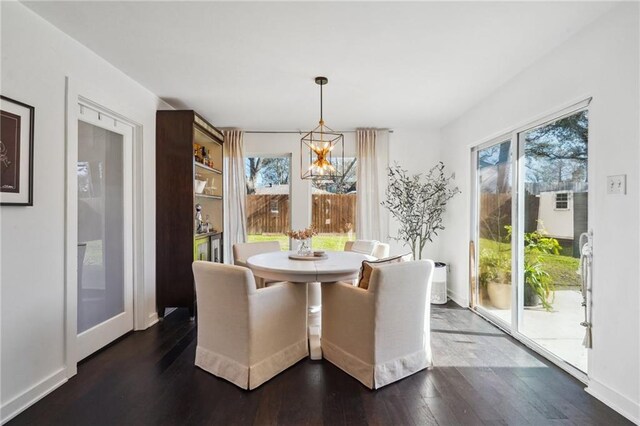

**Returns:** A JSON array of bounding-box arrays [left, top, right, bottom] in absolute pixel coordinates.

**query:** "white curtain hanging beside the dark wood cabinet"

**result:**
[[222, 130, 247, 263]]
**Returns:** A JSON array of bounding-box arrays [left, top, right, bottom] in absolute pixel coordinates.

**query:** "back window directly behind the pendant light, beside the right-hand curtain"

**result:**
[[311, 157, 356, 250]]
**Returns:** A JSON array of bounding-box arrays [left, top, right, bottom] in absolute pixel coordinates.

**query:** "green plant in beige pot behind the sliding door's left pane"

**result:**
[[478, 249, 511, 309]]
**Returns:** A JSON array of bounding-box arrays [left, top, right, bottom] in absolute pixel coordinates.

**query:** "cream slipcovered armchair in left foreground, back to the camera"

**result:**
[[193, 261, 309, 389]]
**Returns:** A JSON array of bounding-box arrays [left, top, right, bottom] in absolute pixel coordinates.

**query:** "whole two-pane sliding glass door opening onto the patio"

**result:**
[[472, 105, 589, 372]]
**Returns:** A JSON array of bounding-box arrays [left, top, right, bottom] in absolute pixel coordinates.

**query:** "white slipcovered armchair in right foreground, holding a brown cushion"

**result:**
[[322, 260, 434, 389]]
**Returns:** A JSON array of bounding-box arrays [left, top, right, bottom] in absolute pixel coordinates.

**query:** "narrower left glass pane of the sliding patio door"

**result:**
[[475, 139, 513, 324]]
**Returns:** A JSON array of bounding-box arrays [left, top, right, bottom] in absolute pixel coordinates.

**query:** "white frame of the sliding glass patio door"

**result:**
[[469, 96, 595, 384]]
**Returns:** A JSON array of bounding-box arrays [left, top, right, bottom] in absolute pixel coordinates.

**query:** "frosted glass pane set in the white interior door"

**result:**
[[78, 122, 124, 333]]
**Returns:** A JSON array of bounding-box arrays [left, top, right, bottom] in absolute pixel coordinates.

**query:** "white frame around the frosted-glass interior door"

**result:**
[[64, 77, 147, 378]]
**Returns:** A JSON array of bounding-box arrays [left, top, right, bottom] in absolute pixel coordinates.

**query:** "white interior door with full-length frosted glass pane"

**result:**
[[77, 106, 133, 360]]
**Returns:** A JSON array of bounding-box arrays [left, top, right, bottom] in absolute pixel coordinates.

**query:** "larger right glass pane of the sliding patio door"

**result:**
[[518, 110, 589, 371]]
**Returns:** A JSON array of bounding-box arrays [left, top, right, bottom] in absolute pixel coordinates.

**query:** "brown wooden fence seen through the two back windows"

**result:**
[[246, 194, 356, 235]]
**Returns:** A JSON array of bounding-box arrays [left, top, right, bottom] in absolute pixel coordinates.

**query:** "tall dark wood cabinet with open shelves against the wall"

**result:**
[[156, 110, 224, 318]]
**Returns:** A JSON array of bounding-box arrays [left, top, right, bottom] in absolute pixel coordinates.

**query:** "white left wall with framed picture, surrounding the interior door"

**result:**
[[0, 2, 168, 421]]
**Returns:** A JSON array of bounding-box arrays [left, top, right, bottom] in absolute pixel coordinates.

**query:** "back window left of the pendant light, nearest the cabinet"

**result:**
[[245, 155, 291, 250]]
